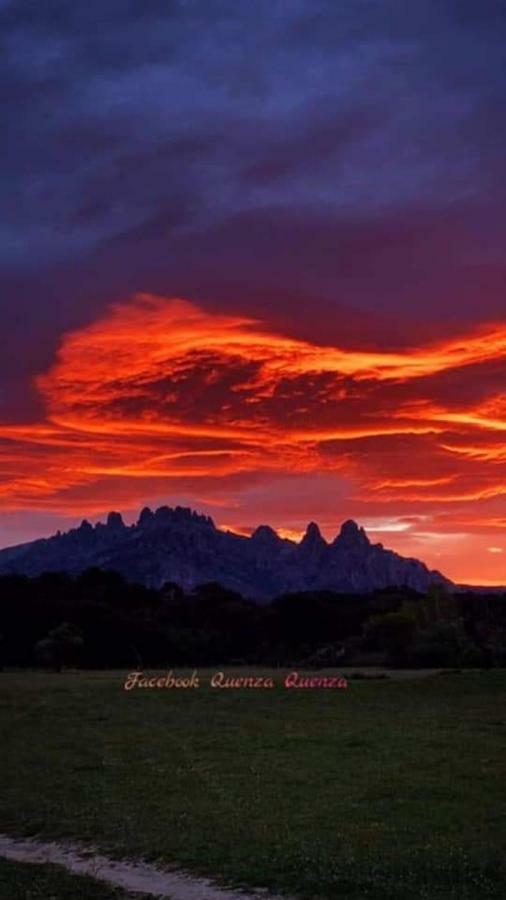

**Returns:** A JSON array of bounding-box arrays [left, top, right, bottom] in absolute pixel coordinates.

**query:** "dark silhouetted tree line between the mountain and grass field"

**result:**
[[0, 569, 506, 671]]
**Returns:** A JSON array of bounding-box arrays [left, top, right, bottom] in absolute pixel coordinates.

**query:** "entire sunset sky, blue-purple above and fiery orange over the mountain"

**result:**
[[0, 0, 506, 584]]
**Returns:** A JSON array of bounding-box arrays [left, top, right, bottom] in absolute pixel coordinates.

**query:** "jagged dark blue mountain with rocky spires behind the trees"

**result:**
[[0, 506, 451, 600]]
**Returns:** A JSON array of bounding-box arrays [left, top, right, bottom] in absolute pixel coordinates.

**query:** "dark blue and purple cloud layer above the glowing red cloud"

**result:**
[[0, 0, 506, 418]]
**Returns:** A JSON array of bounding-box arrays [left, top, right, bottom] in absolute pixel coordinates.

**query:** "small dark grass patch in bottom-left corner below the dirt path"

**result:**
[[0, 859, 153, 900]]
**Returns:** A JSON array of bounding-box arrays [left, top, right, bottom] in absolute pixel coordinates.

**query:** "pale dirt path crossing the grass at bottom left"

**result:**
[[0, 835, 286, 900]]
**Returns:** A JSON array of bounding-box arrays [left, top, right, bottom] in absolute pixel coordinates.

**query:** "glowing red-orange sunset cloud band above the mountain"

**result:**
[[0, 296, 506, 581]]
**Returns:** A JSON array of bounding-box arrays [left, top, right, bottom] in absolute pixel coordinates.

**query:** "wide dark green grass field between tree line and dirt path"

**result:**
[[0, 670, 506, 900]]
